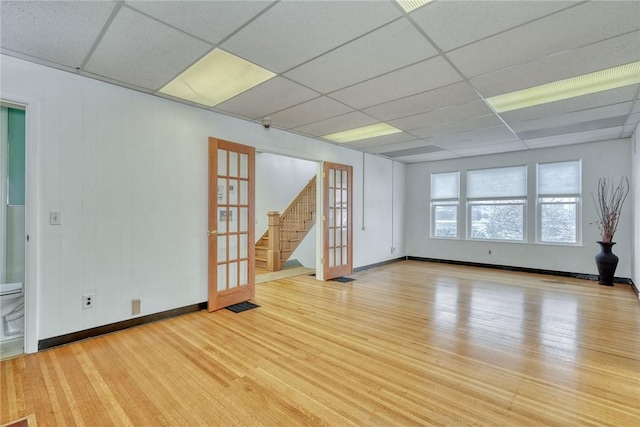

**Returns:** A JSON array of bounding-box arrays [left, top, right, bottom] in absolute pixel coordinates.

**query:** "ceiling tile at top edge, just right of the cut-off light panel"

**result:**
[[411, 1, 577, 51]]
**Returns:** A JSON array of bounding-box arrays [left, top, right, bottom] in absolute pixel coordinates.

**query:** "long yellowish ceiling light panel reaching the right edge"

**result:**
[[487, 61, 640, 113]]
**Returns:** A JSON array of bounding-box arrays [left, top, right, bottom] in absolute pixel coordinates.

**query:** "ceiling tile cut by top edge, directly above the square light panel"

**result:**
[[125, 1, 271, 44]]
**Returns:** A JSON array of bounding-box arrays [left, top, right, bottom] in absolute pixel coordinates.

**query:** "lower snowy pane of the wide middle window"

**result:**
[[470, 202, 524, 240]]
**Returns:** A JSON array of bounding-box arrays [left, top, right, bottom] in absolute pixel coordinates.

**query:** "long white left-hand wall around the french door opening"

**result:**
[[0, 55, 404, 351]]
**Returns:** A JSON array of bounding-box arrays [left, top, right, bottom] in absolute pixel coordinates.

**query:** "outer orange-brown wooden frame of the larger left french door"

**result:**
[[207, 137, 255, 312]]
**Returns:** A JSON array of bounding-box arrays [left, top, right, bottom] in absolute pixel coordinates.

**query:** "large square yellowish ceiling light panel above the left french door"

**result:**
[[160, 48, 276, 107]]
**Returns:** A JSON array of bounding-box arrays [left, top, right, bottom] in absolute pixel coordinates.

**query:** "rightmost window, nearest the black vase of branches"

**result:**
[[537, 160, 582, 244]]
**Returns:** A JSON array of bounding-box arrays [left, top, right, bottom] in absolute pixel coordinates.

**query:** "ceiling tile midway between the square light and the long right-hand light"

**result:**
[[330, 57, 461, 109]]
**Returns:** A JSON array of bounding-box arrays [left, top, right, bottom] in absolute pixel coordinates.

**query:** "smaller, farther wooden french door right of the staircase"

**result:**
[[322, 162, 353, 280]]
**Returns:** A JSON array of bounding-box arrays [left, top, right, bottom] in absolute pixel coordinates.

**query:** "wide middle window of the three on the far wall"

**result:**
[[467, 166, 527, 241]]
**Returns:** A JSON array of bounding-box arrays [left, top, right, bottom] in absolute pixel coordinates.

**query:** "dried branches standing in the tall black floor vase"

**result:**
[[591, 177, 629, 243]]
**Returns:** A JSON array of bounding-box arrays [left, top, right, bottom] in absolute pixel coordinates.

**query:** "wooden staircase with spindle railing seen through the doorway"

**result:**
[[255, 177, 316, 271]]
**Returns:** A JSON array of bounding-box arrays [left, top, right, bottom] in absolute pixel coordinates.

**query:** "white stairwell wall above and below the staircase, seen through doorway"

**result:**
[[256, 153, 318, 268]]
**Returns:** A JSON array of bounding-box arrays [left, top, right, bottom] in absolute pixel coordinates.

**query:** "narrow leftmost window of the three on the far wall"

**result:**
[[431, 172, 460, 237]]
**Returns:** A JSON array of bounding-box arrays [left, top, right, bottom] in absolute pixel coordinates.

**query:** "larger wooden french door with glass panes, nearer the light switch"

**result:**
[[207, 138, 255, 311]]
